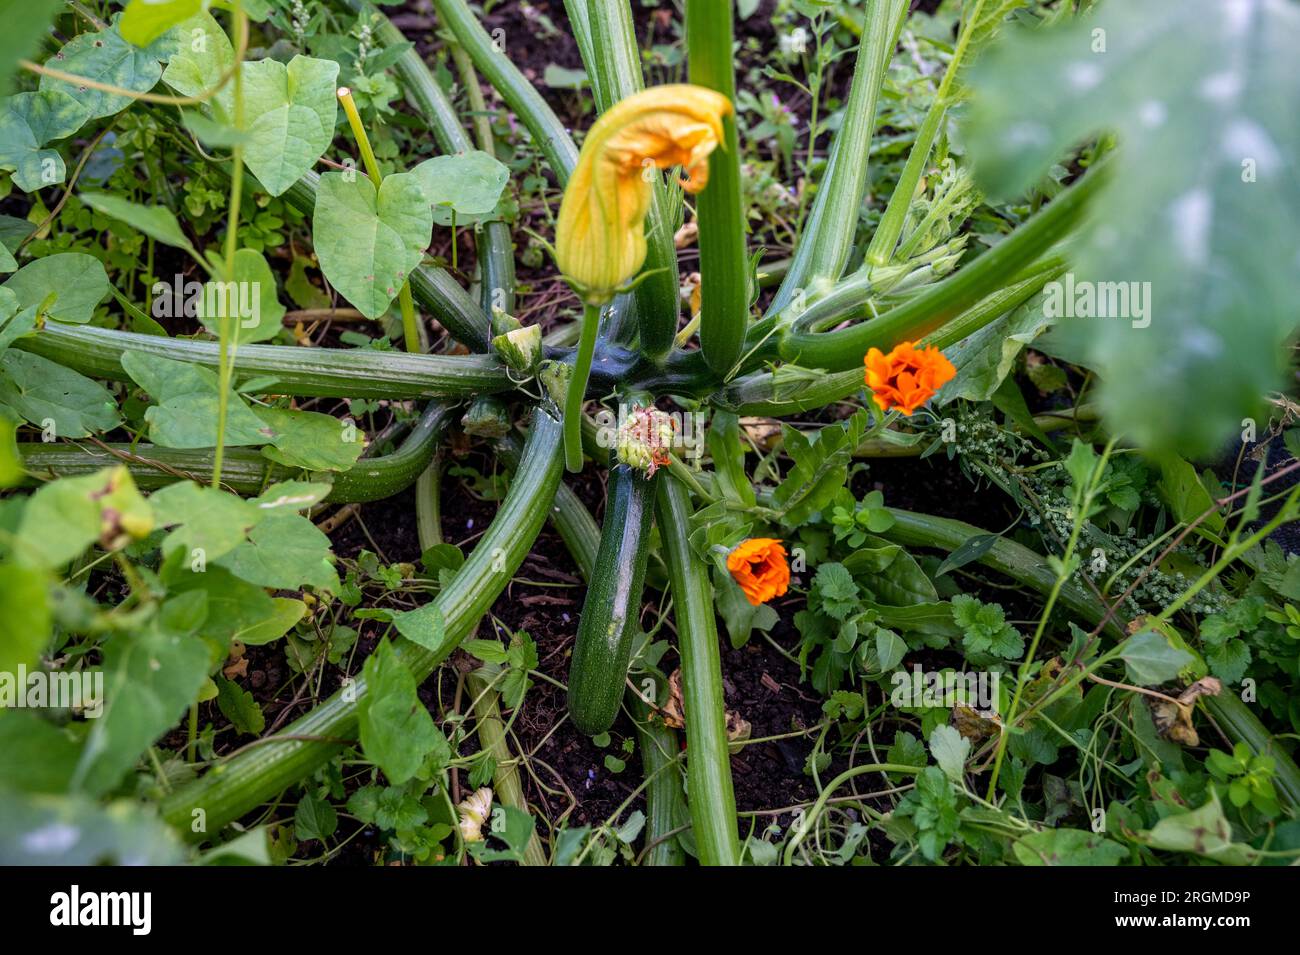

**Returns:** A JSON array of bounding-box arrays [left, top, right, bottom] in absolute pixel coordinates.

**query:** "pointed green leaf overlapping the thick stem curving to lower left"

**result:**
[[356, 641, 446, 785]]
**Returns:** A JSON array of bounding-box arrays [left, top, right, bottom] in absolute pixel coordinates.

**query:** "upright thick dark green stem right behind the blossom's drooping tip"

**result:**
[[686, 0, 749, 376]]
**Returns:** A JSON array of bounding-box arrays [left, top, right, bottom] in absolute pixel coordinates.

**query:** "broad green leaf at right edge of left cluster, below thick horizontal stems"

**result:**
[[217, 512, 339, 592]]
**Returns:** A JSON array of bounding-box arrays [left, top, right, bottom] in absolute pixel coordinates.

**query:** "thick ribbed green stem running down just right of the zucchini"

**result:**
[[655, 474, 740, 865]]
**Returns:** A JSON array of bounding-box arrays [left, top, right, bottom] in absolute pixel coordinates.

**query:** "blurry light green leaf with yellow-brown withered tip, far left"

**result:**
[[14, 465, 153, 568]]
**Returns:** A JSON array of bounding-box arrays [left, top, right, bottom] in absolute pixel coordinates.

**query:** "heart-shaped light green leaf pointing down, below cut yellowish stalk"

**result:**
[[312, 173, 433, 318]]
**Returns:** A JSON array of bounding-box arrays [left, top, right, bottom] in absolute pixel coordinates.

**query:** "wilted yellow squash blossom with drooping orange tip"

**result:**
[[555, 83, 732, 304]]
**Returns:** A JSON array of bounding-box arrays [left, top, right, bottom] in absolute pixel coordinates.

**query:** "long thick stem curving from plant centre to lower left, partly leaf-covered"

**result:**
[[163, 408, 563, 841]]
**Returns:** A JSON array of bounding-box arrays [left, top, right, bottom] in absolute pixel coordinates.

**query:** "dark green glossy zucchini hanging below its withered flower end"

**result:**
[[568, 464, 654, 734]]
